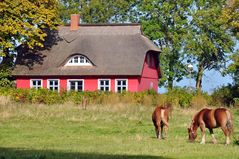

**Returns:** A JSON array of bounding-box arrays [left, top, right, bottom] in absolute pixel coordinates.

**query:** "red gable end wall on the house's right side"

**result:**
[[138, 52, 159, 92]]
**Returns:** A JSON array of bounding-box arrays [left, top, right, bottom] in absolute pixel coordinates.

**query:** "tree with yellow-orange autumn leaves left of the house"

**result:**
[[0, 0, 58, 65]]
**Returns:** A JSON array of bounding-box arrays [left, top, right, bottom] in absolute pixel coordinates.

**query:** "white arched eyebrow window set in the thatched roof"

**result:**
[[66, 55, 92, 66]]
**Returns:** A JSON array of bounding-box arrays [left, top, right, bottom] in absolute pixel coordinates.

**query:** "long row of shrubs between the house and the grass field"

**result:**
[[0, 88, 236, 108]]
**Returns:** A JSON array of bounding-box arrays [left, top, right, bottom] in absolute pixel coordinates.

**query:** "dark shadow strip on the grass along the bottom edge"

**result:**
[[0, 147, 173, 159]]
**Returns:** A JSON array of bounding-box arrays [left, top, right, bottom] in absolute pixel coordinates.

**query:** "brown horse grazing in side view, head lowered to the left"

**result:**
[[188, 108, 233, 144]]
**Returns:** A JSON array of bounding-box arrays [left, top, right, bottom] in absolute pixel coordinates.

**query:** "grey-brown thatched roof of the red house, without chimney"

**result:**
[[13, 24, 160, 76]]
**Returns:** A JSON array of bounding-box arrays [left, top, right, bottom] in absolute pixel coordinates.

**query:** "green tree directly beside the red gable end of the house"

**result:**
[[138, 0, 192, 89]]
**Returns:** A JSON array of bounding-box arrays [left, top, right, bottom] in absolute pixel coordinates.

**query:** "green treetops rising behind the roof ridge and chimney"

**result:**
[[60, 0, 136, 23]]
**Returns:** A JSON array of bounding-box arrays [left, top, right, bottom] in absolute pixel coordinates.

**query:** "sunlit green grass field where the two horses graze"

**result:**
[[0, 101, 239, 159]]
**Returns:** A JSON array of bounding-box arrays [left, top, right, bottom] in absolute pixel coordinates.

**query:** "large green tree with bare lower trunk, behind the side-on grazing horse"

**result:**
[[186, 0, 235, 90]]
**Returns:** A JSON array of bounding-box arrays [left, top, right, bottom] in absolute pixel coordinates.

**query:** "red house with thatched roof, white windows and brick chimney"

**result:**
[[13, 14, 161, 92]]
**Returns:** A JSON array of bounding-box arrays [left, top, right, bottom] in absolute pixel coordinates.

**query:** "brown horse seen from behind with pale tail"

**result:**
[[152, 104, 172, 139]]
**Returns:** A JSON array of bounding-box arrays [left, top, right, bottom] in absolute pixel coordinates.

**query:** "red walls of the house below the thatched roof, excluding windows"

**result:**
[[16, 52, 158, 92]]
